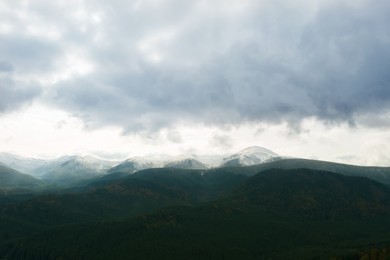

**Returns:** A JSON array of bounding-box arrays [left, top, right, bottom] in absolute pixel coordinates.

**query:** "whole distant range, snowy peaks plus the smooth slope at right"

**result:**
[[0, 146, 390, 192]]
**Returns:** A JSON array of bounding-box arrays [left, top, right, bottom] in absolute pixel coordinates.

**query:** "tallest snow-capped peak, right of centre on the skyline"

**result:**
[[221, 146, 279, 167]]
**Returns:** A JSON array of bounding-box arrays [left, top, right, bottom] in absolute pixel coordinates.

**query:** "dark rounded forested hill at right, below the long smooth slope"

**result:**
[[234, 169, 390, 219]]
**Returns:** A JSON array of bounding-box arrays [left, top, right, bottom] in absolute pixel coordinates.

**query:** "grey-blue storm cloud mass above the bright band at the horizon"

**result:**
[[0, 0, 390, 132]]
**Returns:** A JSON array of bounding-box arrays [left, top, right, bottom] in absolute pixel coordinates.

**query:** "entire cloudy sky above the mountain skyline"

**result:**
[[0, 0, 390, 166]]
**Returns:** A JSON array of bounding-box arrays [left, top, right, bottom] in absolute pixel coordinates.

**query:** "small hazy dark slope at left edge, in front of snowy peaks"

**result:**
[[0, 165, 47, 193]]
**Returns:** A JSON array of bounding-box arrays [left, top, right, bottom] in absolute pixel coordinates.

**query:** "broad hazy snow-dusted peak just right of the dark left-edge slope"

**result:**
[[40, 156, 116, 186]]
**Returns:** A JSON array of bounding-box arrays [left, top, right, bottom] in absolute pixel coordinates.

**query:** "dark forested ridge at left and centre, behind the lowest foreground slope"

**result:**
[[0, 168, 246, 241]]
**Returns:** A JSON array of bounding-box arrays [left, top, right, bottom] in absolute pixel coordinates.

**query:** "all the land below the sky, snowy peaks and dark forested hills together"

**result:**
[[0, 147, 390, 259]]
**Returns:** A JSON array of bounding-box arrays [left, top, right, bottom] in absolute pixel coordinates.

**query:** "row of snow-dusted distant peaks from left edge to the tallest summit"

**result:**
[[0, 146, 279, 187]]
